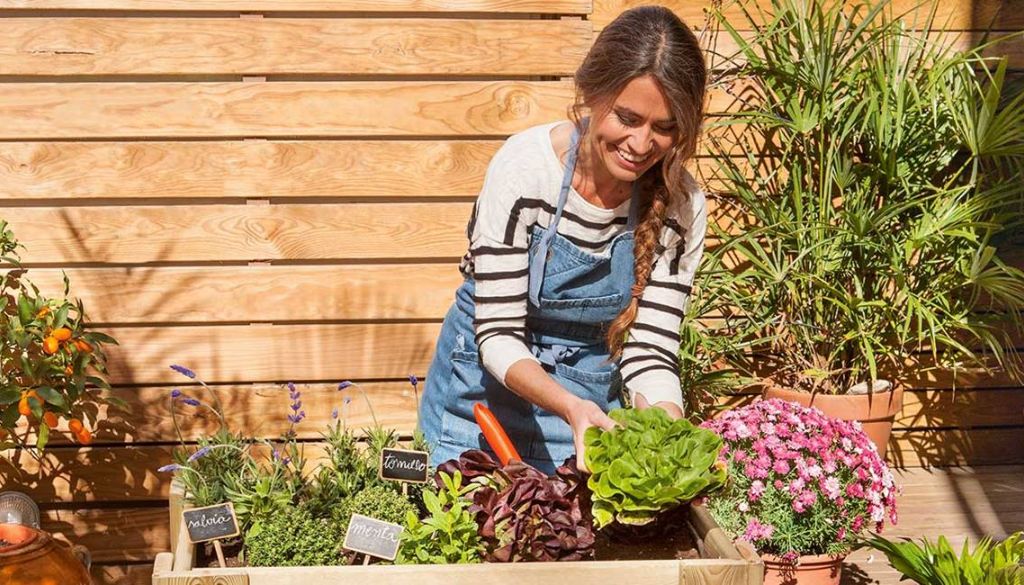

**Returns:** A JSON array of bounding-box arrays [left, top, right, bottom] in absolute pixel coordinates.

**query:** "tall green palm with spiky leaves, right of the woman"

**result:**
[[696, 0, 1024, 393]]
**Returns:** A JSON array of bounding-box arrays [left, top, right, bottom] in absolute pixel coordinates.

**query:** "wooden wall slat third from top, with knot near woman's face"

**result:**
[[0, 81, 572, 139]]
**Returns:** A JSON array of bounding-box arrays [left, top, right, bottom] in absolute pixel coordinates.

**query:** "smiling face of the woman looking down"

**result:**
[[591, 75, 678, 181]]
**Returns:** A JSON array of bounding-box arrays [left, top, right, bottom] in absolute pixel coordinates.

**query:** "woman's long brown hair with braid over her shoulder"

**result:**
[[569, 6, 708, 359]]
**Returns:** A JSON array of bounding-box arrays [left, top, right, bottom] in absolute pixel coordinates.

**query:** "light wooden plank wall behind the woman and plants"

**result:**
[[0, 0, 1024, 583]]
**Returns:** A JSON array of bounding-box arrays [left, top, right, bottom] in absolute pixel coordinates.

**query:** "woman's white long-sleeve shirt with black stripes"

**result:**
[[461, 122, 707, 407]]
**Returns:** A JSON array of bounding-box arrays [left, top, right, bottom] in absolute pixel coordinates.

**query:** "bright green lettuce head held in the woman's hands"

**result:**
[[584, 408, 726, 528]]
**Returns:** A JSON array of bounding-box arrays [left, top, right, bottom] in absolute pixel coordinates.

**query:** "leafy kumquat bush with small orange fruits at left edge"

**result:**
[[0, 219, 118, 456]]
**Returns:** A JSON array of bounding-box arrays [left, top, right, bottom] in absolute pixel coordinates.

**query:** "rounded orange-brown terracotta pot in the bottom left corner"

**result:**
[[0, 524, 92, 585]]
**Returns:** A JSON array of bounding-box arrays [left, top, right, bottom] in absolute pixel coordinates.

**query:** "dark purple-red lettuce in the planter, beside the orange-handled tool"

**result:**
[[435, 450, 594, 562]]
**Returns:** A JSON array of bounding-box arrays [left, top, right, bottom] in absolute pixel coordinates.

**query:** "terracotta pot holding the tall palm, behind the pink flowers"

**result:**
[[764, 385, 903, 457]]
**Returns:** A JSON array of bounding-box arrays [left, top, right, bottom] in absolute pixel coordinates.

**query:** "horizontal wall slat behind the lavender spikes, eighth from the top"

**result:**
[[18, 385, 1024, 447]]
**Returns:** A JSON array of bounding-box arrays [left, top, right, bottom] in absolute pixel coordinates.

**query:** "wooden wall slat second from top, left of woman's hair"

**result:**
[[0, 17, 592, 76]]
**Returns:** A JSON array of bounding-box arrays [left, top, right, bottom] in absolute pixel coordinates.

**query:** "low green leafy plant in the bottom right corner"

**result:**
[[862, 532, 1024, 585]]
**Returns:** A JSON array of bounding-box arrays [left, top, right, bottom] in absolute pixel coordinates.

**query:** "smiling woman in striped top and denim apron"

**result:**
[[420, 6, 707, 472]]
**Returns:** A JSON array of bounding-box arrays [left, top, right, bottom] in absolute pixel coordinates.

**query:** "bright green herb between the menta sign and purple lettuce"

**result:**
[[395, 471, 483, 565]]
